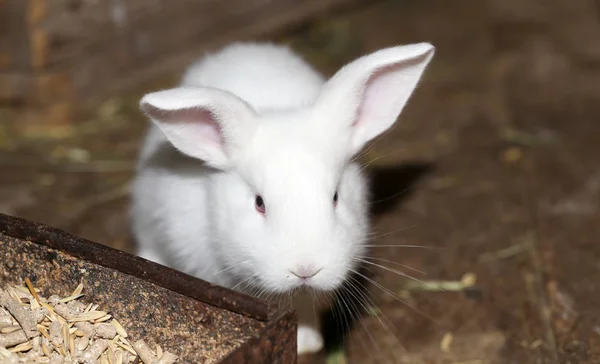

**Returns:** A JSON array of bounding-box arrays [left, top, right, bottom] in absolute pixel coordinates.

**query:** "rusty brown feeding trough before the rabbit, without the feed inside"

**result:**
[[0, 214, 297, 364]]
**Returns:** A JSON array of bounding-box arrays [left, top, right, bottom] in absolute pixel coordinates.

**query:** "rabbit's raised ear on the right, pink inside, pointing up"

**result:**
[[314, 43, 435, 154]]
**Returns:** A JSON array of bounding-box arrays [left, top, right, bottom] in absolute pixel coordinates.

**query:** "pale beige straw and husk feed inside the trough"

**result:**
[[0, 279, 178, 364]]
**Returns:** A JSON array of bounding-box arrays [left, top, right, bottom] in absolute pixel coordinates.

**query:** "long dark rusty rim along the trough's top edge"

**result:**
[[0, 213, 279, 321]]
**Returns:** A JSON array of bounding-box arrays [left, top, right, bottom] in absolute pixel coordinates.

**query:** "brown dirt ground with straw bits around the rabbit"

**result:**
[[0, 0, 600, 364]]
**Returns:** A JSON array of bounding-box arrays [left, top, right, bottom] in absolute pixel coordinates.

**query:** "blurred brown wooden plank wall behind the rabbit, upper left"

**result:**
[[0, 0, 368, 122]]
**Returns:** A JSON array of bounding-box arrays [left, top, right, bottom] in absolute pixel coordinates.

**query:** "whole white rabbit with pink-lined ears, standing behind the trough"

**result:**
[[132, 43, 434, 354]]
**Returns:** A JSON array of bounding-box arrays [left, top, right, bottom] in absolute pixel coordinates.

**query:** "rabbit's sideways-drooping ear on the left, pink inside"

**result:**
[[140, 87, 256, 169]]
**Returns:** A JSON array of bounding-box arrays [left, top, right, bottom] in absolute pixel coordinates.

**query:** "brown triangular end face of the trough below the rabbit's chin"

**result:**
[[219, 311, 298, 364]]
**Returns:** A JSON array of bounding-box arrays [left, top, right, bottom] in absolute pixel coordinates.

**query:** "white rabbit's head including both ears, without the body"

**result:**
[[141, 43, 434, 292]]
